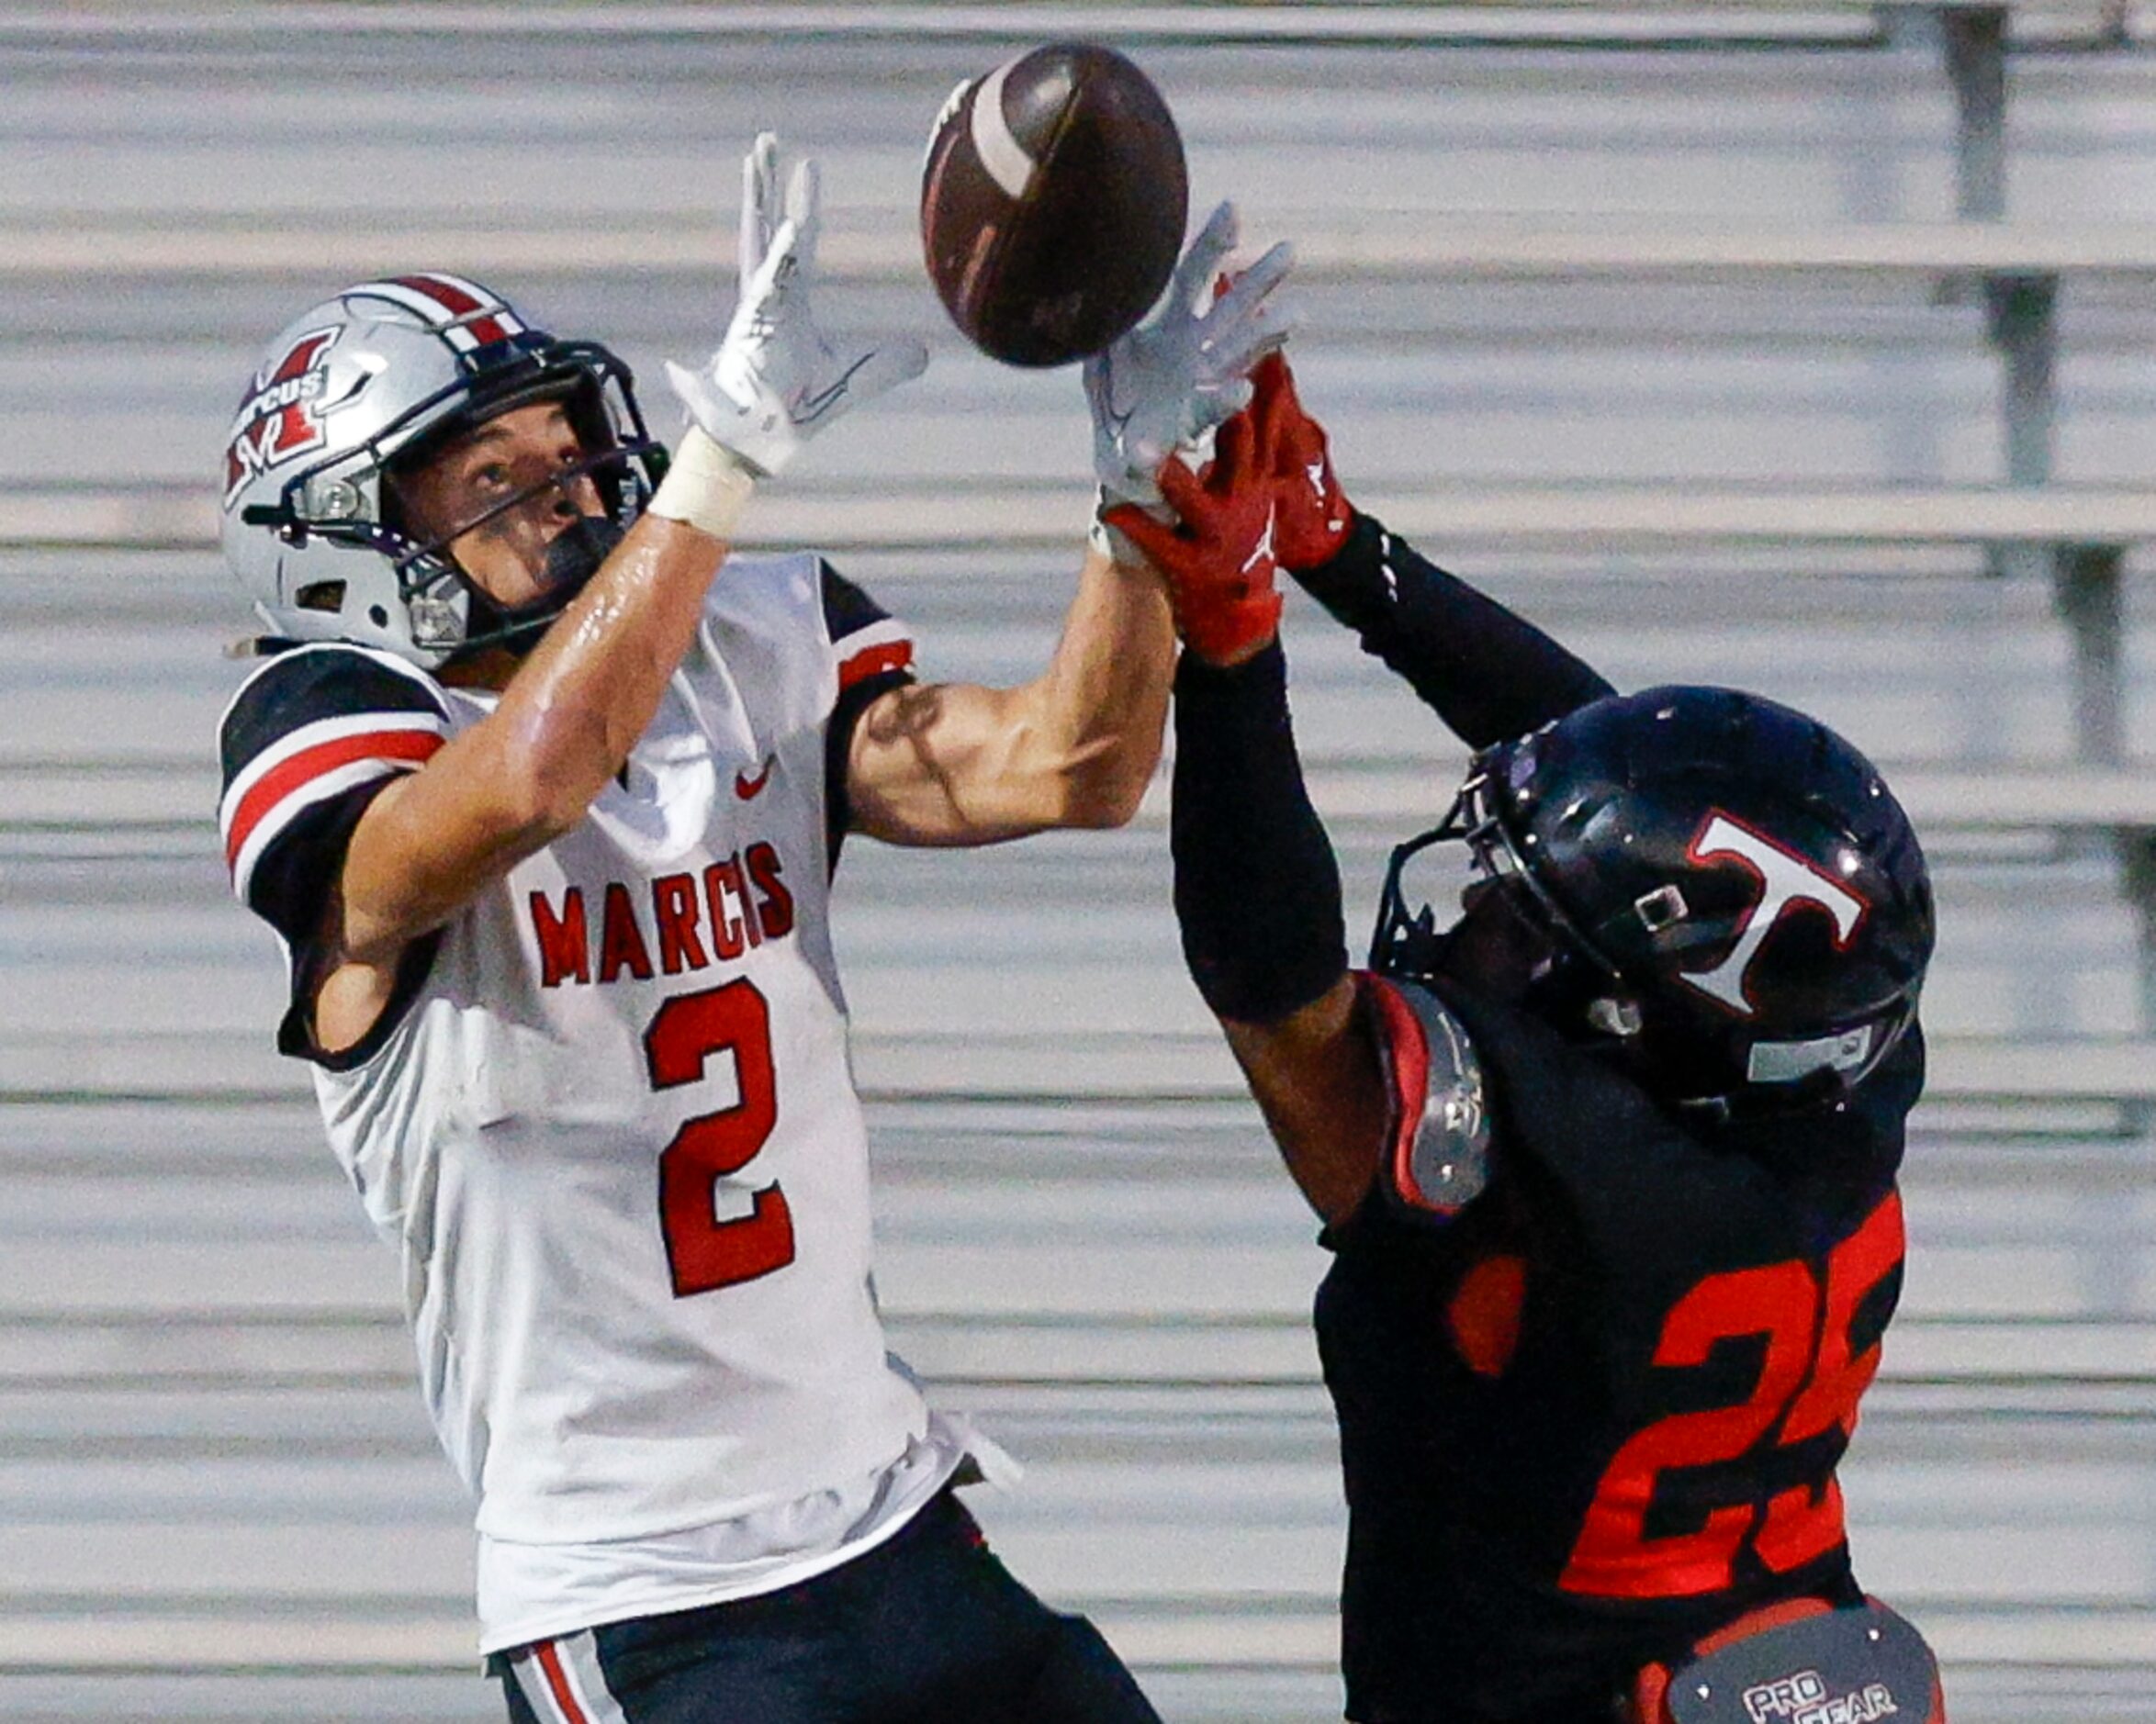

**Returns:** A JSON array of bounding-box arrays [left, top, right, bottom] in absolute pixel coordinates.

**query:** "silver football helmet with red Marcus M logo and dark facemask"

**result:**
[[222, 274, 667, 670]]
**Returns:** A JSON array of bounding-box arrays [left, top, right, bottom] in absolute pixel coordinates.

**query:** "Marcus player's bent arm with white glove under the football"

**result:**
[[848, 205, 1289, 845]]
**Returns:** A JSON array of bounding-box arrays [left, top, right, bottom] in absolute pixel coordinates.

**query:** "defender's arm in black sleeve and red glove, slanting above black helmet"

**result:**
[[1252, 353, 1615, 748]]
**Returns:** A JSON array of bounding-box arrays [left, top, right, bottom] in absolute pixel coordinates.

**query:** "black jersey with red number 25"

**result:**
[[1318, 960, 1923, 1724]]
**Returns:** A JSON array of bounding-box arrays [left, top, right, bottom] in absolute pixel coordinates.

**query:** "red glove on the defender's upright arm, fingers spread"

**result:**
[[1102, 409, 1281, 664]]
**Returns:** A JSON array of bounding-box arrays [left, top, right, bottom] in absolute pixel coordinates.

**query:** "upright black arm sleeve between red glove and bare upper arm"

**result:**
[[1169, 643, 1348, 1024]]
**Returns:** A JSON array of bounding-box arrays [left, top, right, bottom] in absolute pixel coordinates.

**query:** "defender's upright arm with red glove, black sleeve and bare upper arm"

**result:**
[[1113, 402, 1388, 1222]]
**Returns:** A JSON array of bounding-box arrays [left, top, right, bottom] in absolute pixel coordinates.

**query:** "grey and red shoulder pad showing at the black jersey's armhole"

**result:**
[[1367, 976, 1489, 1217]]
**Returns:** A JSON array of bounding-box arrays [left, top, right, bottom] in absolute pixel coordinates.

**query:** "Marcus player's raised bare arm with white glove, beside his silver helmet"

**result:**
[[320, 136, 927, 1030]]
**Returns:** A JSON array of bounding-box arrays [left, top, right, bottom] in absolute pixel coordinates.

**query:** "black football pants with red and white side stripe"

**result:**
[[489, 1491, 1160, 1724]]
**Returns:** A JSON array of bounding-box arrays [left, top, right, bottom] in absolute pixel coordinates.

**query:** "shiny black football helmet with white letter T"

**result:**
[[1371, 688, 1932, 1112]]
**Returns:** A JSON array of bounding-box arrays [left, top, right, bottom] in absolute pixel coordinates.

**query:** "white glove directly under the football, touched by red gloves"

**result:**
[[1084, 203, 1294, 504]]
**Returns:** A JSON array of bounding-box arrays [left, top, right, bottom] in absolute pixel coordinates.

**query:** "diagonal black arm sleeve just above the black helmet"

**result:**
[[1296, 515, 1615, 748]]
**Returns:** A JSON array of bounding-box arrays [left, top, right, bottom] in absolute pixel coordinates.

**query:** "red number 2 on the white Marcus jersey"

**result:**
[[645, 979, 793, 1300]]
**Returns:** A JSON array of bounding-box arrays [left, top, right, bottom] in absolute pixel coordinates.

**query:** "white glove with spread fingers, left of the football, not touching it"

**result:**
[[667, 131, 929, 476]]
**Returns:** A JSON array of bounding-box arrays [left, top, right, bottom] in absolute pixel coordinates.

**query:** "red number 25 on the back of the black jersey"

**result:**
[[1559, 1194, 1902, 1599]]
